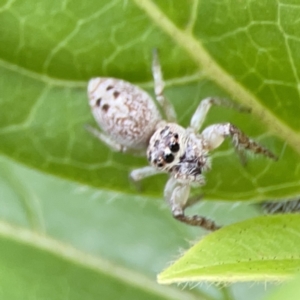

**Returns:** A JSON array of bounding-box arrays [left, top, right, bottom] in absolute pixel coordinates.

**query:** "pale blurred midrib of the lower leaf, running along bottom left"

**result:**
[[0, 221, 203, 300]]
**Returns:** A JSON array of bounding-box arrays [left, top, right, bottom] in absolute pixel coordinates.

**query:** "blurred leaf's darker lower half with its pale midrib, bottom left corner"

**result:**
[[0, 218, 200, 299]]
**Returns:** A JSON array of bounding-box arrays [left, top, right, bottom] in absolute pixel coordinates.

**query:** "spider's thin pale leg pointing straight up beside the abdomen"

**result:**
[[152, 49, 176, 122]]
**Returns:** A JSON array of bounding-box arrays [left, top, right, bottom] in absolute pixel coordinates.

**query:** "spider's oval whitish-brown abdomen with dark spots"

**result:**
[[88, 77, 161, 149]]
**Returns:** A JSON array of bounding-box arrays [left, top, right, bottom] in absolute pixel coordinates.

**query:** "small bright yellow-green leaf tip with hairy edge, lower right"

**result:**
[[158, 215, 300, 283]]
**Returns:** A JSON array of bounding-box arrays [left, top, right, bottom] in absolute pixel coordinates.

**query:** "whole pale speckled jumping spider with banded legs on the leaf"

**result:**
[[87, 50, 277, 230]]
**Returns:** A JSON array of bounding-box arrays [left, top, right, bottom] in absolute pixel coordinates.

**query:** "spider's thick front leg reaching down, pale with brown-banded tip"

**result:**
[[164, 177, 220, 231]]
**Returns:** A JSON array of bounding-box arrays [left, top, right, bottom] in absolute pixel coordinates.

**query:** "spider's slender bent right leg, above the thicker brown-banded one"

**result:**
[[190, 97, 250, 131]]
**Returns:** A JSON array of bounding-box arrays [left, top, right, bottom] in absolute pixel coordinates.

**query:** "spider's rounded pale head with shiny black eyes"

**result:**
[[147, 123, 185, 171]]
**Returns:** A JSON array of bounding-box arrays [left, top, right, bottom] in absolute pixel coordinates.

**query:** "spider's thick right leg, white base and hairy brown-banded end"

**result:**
[[201, 123, 277, 161]]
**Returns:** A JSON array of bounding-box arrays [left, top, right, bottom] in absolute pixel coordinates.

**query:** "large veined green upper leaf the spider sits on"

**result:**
[[0, 0, 300, 200]]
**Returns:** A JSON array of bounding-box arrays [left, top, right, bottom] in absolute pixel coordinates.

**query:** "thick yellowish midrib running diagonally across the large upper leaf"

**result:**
[[134, 0, 300, 154]]
